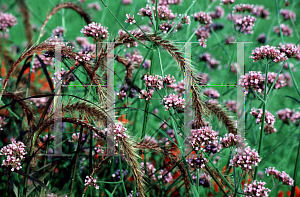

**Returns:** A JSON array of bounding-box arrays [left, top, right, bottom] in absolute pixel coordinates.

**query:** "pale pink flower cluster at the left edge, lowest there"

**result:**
[[0, 141, 27, 171]]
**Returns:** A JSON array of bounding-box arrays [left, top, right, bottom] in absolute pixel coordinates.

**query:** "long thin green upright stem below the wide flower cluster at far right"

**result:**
[[253, 61, 269, 180]]
